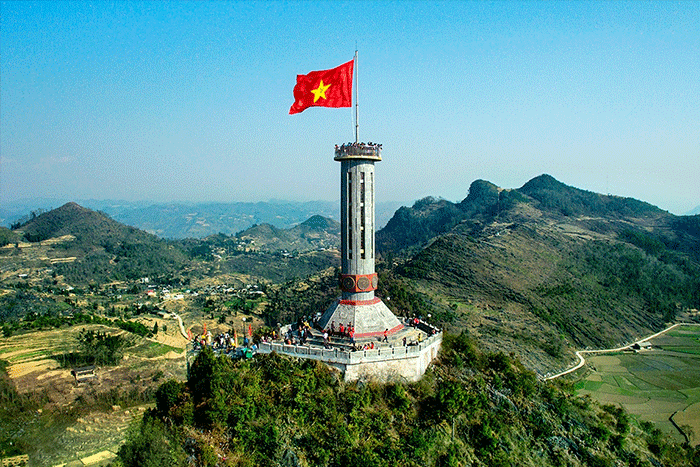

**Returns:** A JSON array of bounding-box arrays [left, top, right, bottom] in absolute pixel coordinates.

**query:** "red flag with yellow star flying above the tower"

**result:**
[[289, 60, 355, 115]]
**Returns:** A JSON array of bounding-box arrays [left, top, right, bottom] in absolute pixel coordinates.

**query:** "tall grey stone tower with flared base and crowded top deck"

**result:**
[[319, 143, 403, 340]]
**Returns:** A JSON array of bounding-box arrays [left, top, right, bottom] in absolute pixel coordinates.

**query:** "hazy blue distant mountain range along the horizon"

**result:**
[[0, 199, 402, 239]]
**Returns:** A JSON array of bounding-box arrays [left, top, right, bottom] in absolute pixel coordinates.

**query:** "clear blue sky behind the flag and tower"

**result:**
[[0, 1, 700, 214]]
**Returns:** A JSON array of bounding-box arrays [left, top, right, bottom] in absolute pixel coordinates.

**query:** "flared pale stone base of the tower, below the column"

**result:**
[[318, 298, 403, 340]]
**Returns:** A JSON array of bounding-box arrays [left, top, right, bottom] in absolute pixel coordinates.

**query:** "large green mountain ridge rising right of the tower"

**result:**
[[377, 175, 700, 372]]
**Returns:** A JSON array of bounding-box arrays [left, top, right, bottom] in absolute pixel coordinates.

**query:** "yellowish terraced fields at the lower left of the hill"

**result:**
[[0, 320, 185, 467]]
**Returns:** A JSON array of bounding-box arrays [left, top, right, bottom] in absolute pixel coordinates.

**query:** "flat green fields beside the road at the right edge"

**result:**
[[576, 326, 700, 445]]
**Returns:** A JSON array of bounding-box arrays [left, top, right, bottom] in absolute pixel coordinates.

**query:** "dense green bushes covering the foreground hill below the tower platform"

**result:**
[[119, 334, 700, 466]]
